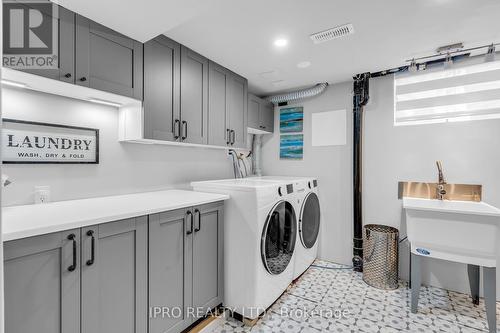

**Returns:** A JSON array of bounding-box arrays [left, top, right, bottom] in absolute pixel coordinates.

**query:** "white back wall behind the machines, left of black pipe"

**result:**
[[262, 82, 352, 264]]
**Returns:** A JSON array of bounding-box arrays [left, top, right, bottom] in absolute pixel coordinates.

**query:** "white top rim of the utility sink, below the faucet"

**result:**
[[403, 197, 500, 217]]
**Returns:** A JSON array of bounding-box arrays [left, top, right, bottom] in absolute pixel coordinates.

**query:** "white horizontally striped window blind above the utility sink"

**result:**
[[394, 57, 500, 125]]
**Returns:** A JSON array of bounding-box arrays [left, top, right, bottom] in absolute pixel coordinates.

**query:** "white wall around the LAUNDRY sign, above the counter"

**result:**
[[2, 88, 233, 206]]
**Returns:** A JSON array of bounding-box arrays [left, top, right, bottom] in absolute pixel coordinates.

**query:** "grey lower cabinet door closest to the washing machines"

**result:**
[[193, 203, 224, 312]]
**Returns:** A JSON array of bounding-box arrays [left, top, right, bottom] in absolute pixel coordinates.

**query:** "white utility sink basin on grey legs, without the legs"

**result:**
[[403, 197, 500, 267]]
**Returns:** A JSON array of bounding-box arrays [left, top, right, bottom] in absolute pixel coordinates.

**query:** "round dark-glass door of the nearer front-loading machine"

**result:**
[[260, 201, 297, 274]]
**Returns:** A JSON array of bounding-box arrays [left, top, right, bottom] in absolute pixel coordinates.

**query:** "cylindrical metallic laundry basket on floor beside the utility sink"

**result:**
[[363, 224, 399, 290]]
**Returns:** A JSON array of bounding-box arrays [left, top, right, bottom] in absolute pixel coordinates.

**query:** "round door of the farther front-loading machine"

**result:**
[[299, 192, 320, 249]]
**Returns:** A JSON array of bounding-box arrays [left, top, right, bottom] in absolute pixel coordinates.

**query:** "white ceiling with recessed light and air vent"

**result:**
[[54, 0, 500, 95]]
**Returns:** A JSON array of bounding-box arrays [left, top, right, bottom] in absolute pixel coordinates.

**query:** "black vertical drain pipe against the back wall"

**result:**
[[352, 73, 370, 272]]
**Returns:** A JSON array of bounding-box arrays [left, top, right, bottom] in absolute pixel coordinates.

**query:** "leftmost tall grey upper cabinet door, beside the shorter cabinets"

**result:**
[[144, 36, 180, 141]]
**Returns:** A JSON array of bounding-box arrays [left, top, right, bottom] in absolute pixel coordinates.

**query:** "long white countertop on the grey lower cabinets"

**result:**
[[2, 190, 229, 241]]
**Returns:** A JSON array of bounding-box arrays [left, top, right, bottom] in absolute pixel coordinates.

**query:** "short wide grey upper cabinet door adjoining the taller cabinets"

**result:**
[[76, 15, 143, 99]]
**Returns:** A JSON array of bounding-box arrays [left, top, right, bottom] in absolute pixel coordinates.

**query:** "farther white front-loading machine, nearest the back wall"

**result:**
[[258, 176, 321, 279]]
